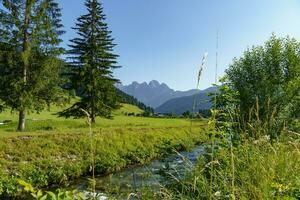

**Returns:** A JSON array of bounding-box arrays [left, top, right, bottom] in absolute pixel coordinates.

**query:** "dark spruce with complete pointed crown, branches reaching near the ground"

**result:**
[[59, 0, 118, 123]]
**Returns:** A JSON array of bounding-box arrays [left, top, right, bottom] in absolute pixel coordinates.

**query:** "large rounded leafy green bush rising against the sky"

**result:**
[[217, 35, 300, 138]]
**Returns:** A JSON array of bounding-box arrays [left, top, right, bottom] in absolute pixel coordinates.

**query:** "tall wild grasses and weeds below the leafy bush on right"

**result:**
[[161, 135, 300, 200]]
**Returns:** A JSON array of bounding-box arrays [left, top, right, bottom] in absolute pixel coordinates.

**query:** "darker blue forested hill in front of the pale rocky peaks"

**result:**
[[155, 87, 216, 115]]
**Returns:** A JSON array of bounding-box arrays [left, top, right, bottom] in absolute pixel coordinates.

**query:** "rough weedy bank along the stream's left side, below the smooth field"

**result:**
[[0, 125, 207, 199]]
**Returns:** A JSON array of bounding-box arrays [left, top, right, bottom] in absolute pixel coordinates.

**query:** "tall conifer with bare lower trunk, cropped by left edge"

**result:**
[[0, 0, 64, 131]]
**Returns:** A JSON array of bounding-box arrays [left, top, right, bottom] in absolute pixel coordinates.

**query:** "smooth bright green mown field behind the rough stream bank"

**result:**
[[0, 104, 197, 137]]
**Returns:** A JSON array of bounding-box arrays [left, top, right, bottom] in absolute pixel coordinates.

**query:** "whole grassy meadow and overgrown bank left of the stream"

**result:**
[[0, 104, 207, 198]]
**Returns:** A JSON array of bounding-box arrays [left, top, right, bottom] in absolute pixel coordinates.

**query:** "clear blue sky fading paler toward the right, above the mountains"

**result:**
[[58, 0, 300, 90]]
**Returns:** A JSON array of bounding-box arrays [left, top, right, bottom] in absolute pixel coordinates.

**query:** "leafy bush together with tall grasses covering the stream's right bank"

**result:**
[[160, 35, 300, 199]]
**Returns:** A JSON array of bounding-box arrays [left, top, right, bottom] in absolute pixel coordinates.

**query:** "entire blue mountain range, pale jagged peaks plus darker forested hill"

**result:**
[[116, 80, 216, 115]]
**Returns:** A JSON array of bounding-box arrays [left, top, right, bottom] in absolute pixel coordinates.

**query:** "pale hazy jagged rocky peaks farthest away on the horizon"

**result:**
[[117, 80, 199, 108]]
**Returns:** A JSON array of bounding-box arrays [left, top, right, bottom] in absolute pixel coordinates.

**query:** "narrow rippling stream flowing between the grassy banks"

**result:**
[[67, 145, 204, 200]]
